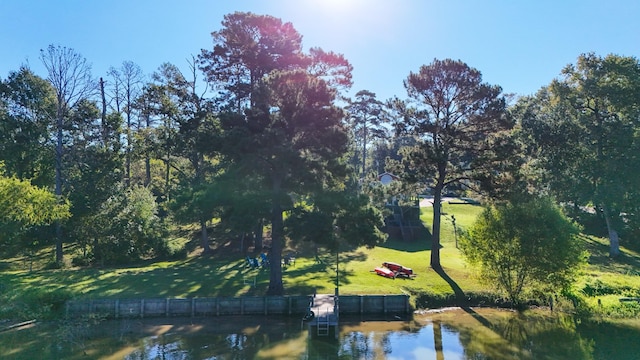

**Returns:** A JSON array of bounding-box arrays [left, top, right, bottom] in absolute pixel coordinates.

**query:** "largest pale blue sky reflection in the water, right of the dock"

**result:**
[[387, 324, 465, 360]]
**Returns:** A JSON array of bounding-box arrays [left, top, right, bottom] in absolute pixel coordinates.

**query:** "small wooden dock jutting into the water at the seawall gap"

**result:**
[[308, 294, 339, 339]]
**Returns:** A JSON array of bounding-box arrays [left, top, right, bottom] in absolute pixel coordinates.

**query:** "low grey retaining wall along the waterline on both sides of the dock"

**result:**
[[66, 294, 411, 319]]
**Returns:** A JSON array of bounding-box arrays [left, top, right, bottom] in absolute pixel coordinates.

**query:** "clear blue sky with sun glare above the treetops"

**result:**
[[0, 0, 640, 100]]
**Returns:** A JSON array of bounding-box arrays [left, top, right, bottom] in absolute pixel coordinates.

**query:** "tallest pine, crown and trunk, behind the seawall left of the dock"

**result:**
[[200, 13, 370, 294]]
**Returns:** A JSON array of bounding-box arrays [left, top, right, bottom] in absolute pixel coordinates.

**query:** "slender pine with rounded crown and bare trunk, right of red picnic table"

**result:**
[[393, 59, 512, 269]]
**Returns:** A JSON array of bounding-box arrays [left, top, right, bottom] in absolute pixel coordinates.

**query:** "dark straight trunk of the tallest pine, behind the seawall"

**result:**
[[267, 174, 284, 295]]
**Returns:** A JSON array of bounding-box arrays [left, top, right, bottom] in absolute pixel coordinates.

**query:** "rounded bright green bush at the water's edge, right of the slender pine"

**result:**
[[460, 198, 586, 303]]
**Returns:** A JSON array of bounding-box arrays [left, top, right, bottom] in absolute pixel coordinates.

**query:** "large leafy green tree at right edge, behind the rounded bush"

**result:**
[[517, 53, 640, 256]]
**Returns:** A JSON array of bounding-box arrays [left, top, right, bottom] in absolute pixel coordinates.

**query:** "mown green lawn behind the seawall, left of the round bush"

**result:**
[[0, 205, 481, 298]]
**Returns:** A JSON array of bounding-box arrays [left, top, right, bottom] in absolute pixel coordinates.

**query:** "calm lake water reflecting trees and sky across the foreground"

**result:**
[[0, 309, 640, 360]]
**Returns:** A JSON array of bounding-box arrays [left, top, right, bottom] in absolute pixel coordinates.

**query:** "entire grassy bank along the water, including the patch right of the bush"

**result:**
[[0, 204, 640, 318]]
